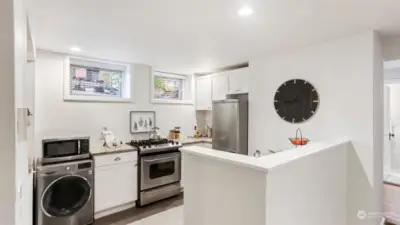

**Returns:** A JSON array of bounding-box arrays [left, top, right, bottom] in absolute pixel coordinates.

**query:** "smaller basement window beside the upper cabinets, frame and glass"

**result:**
[[151, 71, 193, 104]]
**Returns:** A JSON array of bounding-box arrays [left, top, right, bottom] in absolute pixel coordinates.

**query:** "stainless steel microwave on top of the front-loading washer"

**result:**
[[42, 137, 90, 164]]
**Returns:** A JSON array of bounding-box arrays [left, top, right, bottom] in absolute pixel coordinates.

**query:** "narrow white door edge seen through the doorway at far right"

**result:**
[[383, 86, 394, 175]]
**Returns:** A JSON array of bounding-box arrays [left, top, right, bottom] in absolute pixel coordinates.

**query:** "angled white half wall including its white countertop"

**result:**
[[182, 138, 352, 225]]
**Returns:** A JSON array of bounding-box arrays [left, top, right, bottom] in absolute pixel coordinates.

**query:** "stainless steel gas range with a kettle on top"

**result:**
[[128, 139, 182, 206]]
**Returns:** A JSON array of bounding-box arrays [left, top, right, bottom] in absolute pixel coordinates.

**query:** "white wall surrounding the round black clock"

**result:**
[[249, 32, 383, 225]]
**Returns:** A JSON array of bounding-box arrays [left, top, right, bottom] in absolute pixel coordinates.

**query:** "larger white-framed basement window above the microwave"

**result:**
[[64, 57, 133, 102]]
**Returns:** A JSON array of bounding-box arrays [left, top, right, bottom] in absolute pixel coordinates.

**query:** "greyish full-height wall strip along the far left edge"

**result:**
[[0, 0, 16, 225]]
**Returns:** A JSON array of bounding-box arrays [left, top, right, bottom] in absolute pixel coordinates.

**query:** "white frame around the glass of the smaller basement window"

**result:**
[[150, 70, 194, 105]]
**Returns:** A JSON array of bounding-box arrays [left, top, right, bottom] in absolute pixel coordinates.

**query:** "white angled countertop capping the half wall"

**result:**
[[181, 138, 350, 172]]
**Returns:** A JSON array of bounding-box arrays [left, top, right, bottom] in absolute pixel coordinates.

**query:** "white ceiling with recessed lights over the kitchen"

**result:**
[[29, 0, 400, 73]]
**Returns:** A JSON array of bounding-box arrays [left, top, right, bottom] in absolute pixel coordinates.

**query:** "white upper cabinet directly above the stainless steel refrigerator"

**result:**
[[226, 68, 249, 94]]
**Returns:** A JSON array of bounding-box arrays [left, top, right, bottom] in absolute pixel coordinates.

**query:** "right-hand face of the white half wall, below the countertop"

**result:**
[[266, 143, 348, 225]]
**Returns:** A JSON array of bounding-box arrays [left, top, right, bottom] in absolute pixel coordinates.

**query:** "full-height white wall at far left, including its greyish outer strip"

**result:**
[[0, 0, 32, 225]]
